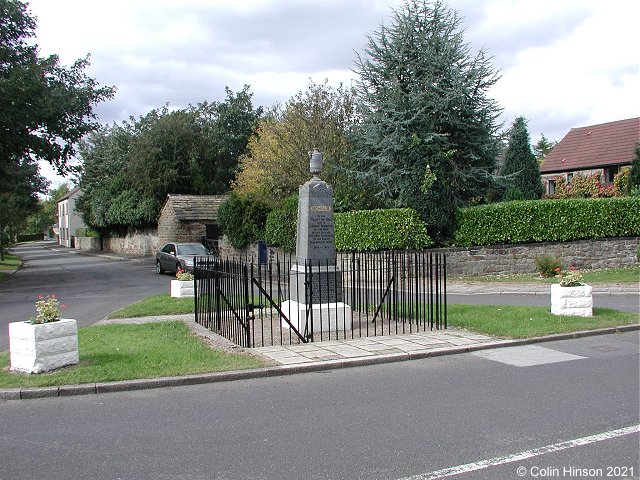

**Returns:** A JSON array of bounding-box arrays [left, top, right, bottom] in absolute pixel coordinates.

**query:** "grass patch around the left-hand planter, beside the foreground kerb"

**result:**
[[0, 321, 265, 388]]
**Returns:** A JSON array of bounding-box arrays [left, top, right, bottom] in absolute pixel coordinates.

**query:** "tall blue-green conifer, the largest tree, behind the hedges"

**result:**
[[353, 0, 500, 241]]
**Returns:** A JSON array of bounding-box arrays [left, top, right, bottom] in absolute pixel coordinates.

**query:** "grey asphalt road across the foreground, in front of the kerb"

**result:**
[[0, 332, 640, 480]]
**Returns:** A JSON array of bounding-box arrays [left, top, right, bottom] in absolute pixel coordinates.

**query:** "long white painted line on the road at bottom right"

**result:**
[[398, 424, 640, 480]]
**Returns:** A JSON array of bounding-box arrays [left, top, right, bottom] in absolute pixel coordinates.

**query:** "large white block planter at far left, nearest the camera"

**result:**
[[9, 318, 80, 373]]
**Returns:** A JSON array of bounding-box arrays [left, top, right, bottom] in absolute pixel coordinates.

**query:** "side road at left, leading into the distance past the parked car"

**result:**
[[0, 242, 171, 351]]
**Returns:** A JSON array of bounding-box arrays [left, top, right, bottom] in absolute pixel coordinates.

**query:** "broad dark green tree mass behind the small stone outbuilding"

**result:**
[[77, 87, 262, 232]]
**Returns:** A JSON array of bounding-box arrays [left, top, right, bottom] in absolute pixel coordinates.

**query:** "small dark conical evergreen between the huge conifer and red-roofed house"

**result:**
[[500, 117, 544, 200]]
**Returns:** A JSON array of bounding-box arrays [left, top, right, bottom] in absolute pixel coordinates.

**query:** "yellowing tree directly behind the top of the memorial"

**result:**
[[233, 82, 354, 210]]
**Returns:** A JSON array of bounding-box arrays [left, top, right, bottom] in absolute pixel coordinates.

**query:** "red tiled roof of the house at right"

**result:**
[[540, 117, 640, 173]]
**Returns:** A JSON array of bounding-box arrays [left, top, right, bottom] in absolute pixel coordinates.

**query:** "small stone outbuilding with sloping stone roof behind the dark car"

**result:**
[[158, 194, 227, 248]]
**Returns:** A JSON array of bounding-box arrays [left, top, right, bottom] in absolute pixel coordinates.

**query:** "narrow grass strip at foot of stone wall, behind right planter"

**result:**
[[447, 267, 640, 284]]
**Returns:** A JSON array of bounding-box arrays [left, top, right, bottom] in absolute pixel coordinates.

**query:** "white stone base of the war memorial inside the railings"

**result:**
[[280, 300, 352, 335]]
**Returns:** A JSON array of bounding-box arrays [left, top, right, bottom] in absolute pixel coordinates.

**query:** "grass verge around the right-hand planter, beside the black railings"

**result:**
[[447, 304, 640, 338]]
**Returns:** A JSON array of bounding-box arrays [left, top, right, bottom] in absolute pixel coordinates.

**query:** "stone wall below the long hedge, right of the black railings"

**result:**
[[433, 237, 640, 275]]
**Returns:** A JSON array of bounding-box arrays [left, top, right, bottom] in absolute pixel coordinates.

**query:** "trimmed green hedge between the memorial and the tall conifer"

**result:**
[[335, 208, 433, 251]]
